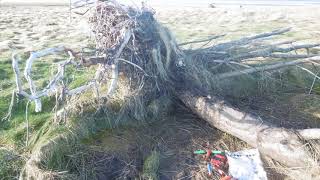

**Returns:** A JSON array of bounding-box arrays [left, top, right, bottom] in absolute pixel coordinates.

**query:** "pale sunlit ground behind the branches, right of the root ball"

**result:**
[[155, 6, 320, 42]]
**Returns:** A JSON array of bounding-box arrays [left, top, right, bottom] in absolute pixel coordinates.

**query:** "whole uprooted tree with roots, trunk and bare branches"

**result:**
[[6, 1, 320, 179]]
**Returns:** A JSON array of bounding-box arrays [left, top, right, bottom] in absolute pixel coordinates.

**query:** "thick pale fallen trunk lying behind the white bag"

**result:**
[[178, 91, 320, 169]]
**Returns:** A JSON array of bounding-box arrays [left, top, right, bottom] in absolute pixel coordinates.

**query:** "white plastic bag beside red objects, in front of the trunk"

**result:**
[[226, 149, 267, 180]]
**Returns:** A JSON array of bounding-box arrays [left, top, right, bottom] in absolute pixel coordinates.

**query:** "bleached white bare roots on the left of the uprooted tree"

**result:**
[[12, 30, 131, 112]]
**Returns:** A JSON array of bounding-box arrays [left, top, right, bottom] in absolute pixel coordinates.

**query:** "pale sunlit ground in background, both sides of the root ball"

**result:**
[[0, 0, 320, 57]]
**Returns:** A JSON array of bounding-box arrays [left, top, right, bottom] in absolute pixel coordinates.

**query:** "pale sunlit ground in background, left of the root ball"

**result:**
[[0, 6, 89, 57]]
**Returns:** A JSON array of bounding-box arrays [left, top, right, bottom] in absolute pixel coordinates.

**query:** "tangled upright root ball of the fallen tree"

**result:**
[[86, 1, 183, 121]]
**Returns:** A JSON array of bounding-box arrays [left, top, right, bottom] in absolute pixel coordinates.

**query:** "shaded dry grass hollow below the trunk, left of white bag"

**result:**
[[82, 103, 252, 179]]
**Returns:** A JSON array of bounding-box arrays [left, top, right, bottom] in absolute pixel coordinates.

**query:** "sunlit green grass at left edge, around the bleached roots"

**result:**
[[0, 48, 96, 180]]
